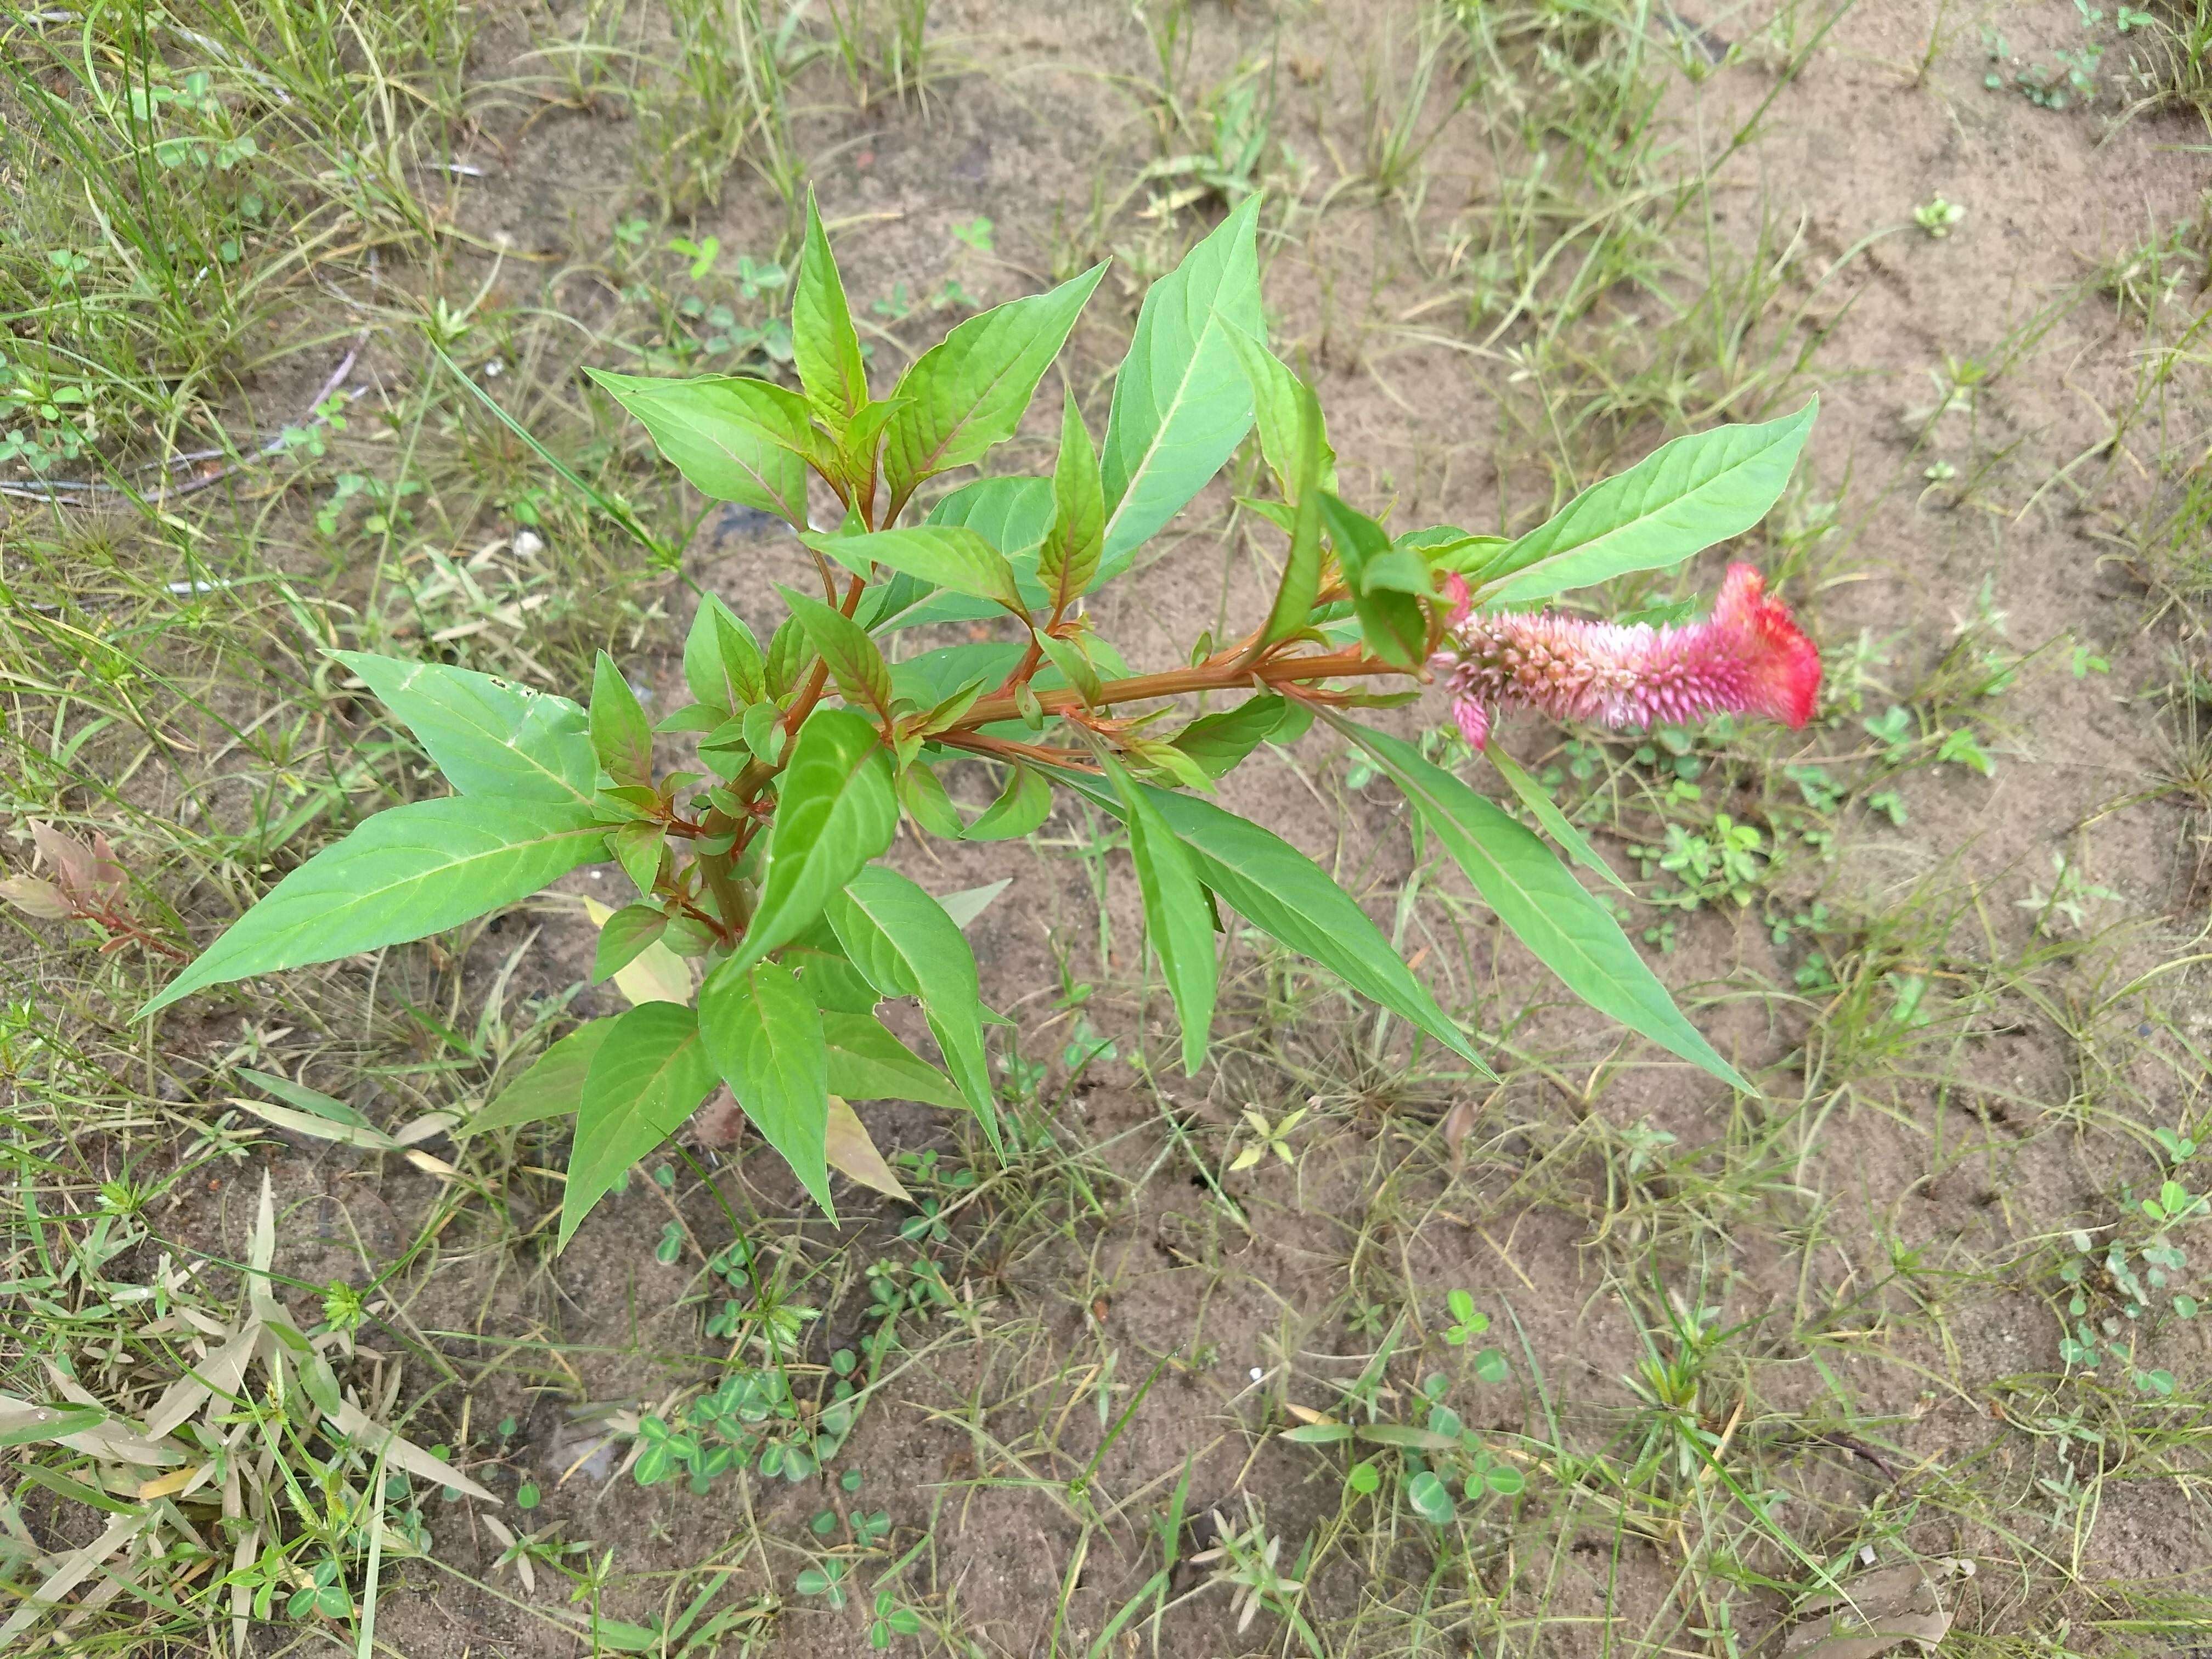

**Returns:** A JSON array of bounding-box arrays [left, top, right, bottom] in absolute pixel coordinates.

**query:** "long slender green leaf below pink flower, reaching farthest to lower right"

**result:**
[[1323, 710, 1758, 1095]]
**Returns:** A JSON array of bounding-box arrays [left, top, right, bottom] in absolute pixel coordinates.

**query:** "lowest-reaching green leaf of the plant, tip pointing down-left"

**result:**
[[549, 1002, 714, 1250]]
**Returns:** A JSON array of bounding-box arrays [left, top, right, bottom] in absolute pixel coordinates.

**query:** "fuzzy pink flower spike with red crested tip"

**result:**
[[1434, 564, 1820, 748]]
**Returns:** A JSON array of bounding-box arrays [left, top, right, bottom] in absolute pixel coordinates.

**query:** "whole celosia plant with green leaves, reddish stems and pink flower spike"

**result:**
[[133, 201, 1818, 1243]]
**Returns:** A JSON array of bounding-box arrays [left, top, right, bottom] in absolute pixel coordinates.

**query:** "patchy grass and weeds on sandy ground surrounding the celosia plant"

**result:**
[[0, 0, 2212, 1659]]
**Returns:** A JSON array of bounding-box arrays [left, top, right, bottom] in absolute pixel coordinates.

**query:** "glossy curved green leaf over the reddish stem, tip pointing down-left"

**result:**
[[730, 708, 898, 978]]
